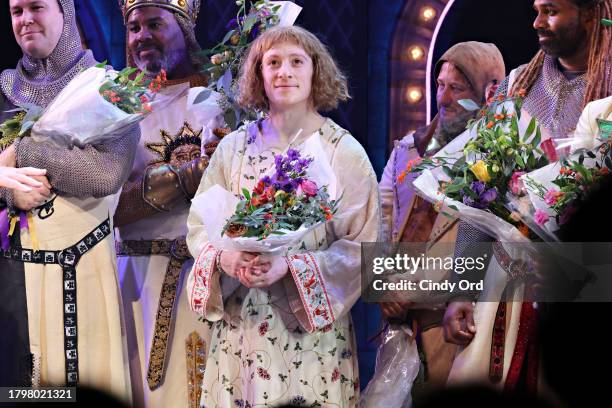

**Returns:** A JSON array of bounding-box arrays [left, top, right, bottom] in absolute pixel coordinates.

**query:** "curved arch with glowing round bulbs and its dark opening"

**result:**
[[388, 0, 539, 148]]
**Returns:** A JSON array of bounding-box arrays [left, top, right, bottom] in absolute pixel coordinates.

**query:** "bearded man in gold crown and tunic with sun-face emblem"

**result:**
[[115, 0, 221, 407]]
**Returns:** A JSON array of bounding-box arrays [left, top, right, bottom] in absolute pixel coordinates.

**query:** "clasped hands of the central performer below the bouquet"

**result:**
[[220, 251, 289, 288]]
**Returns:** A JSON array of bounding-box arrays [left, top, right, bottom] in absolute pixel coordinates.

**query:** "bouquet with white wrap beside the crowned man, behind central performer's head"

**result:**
[[195, 0, 302, 130]]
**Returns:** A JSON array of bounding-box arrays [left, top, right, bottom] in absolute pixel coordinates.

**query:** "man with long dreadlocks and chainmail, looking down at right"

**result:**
[[444, 0, 612, 391]]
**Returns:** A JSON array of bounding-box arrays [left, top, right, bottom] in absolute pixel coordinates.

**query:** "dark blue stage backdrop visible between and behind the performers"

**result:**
[[0, 0, 537, 394]]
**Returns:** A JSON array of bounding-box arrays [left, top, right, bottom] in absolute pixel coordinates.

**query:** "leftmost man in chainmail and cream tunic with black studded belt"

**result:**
[[0, 0, 140, 401]]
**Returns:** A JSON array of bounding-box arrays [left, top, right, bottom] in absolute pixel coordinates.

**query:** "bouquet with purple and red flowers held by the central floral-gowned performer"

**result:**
[[192, 134, 340, 252]]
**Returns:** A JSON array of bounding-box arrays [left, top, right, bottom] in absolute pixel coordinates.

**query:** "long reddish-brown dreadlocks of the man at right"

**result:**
[[511, 0, 612, 107]]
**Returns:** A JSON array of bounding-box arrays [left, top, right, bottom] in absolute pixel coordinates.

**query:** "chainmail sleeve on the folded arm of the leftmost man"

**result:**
[[15, 125, 140, 198]]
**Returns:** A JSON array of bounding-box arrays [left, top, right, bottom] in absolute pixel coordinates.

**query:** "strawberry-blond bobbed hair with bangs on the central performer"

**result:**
[[238, 26, 350, 111]]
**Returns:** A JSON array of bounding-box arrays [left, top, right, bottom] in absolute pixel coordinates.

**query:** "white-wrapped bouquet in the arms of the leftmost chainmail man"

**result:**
[[0, 63, 168, 147]]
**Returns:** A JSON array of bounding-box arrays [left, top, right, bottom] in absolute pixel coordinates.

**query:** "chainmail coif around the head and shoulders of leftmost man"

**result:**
[[0, 0, 96, 107]]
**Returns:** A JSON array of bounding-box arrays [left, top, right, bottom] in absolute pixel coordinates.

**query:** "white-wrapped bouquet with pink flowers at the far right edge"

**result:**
[[521, 135, 612, 239]]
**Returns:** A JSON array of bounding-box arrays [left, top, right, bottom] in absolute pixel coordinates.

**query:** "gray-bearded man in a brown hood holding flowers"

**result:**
[[380, 41, 505, 387]]
